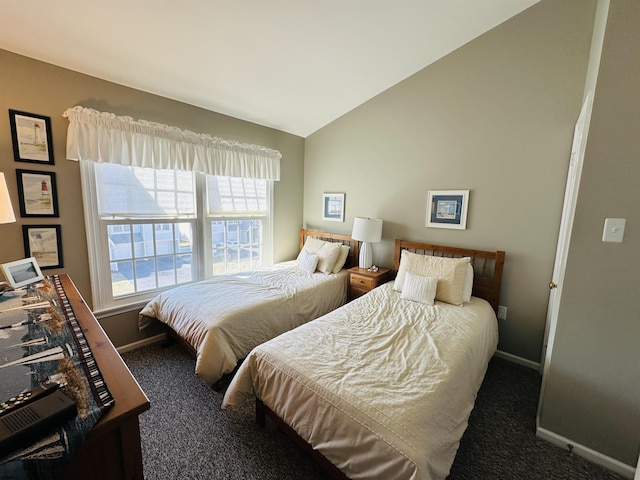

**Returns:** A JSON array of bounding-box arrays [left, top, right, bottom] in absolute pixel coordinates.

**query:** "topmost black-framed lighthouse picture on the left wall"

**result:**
[[9, 109, 53, 165]]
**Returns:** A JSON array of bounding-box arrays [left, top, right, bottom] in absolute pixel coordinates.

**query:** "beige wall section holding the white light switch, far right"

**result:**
[[540, 0, 640, 466]]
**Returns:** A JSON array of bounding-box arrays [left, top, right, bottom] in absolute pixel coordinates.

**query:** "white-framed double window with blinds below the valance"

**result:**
[[81, 161, 272, 310]]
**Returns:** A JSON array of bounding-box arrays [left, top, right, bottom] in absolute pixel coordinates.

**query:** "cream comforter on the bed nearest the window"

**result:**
[[140, 262, 348, 384]]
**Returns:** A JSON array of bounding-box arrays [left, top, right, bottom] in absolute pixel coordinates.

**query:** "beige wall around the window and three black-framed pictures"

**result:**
[[0, 50, 304, 346]]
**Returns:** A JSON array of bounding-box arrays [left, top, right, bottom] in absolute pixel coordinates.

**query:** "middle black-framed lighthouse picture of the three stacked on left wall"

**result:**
[[16, 169, 60, 217]]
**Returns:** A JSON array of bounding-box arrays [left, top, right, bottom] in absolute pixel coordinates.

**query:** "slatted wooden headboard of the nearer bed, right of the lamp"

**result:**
[[393, 239, 505, 313]]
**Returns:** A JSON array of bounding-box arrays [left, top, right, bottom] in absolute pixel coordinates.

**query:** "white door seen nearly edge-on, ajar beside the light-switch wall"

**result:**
[[538, 92, 593, 424]]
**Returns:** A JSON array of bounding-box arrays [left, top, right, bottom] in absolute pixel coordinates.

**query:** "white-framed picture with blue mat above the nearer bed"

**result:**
[[425, 190, 469, 230]]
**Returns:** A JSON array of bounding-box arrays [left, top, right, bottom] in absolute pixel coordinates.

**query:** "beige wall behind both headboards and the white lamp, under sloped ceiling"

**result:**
[[304, 0, 595, 362]]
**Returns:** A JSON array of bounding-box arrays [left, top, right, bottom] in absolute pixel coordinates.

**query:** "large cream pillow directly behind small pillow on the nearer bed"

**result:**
[[393, 250, 471, 305]]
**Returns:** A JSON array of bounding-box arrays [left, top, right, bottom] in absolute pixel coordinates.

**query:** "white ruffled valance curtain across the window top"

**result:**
[[62, 106, 282, 180]]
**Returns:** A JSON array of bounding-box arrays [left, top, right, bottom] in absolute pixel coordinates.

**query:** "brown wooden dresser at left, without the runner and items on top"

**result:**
[[60, 275, 150, 480]]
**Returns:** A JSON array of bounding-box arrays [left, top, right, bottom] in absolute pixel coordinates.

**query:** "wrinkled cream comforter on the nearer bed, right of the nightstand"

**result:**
[[223, 283, 498, 479]]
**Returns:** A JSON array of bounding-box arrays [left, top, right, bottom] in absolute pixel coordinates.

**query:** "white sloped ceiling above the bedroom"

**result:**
[[0, 0, 539, 137]]
